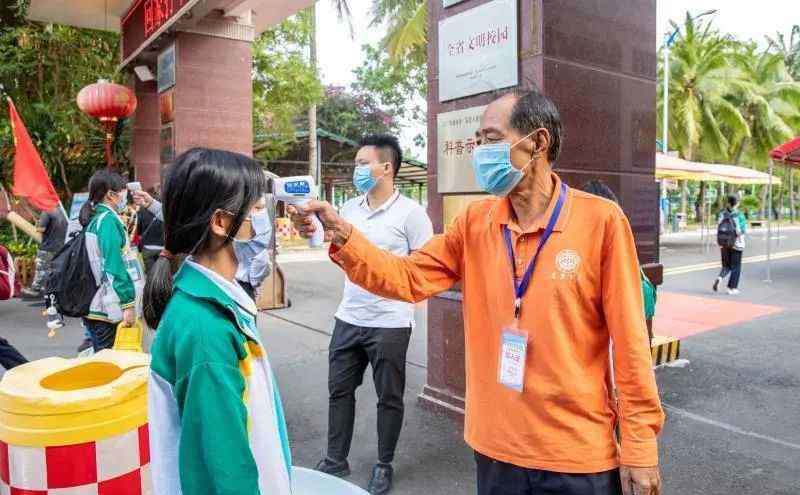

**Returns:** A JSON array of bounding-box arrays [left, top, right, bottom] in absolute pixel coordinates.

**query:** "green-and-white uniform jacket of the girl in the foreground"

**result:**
[[148, 258, 291, 495]]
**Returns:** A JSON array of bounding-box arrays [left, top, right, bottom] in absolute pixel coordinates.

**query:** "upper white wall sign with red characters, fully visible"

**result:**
[[439, 0, 519, 101]]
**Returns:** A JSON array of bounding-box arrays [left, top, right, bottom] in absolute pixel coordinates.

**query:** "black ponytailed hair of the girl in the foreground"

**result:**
[[142, 148, 267, 329]]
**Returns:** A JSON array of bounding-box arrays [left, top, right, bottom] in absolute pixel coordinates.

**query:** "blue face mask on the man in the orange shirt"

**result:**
[[472, 133, 533, 197]]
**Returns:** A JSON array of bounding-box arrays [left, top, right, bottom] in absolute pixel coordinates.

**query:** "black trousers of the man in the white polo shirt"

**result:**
[[328, 319, 411, 464]]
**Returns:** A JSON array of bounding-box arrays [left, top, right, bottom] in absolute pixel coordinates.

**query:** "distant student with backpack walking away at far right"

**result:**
[[712, 194, 747, 296]]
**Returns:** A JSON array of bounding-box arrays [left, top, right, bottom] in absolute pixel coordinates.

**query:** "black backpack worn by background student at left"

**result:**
[[44, 230, 98, 318]]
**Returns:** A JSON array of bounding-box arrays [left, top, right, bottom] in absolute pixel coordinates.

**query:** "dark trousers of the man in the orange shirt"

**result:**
[[475, 452, 622, 495]]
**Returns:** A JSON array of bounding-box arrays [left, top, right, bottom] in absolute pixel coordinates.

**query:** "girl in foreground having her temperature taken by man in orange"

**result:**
[[144, 148, 291, 495]]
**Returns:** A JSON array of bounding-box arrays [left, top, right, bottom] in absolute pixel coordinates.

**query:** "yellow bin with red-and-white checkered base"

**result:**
[[0, 350, 152, 495]]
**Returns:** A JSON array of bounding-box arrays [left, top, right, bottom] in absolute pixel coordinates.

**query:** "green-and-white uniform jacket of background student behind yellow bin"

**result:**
[[86, 204, 144, 323]]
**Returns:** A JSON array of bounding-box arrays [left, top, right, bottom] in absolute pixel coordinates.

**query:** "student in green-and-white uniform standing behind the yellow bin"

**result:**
[[79, 169, 143, 352]]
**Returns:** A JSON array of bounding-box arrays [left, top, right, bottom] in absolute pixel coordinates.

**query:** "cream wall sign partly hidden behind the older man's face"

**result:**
[[436, 106, 486, 193]]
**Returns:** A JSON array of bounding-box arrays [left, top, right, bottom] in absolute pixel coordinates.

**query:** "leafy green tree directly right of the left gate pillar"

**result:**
[[253, 12, 323, 160]]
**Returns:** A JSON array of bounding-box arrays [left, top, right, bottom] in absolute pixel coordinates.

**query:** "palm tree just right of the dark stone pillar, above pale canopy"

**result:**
[[659, 12, 750, 220]]
